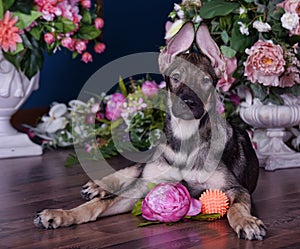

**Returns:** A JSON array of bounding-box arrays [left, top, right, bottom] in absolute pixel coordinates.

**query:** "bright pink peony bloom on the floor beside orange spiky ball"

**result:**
[[142, 183, 201, 222]]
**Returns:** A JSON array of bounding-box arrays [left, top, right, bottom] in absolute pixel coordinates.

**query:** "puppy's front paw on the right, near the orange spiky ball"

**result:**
[[235, 216, 267, 240]]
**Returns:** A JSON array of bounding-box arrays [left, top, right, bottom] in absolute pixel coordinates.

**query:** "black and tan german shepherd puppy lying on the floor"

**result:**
[[34, 23, 266, 240]]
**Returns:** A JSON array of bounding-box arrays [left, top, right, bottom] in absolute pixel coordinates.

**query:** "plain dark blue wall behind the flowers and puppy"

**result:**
[[23, 0, 180, 108]]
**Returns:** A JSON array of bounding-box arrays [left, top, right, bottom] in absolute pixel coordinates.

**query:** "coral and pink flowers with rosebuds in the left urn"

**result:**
[[0, 0, 105, 78]]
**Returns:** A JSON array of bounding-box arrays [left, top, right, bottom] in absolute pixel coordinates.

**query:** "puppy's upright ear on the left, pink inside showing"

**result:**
[[158, 22, 195, 73]]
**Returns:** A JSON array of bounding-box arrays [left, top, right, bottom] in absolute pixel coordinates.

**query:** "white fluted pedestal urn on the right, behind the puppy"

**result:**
[[240, 95, 300, 171]]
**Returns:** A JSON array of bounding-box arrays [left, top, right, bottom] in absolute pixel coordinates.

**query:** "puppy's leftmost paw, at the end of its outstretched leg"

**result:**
[[33, 209, 66, 229]]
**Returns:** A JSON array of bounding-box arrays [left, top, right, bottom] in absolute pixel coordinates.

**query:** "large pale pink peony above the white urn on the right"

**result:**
[[244, 41, 285, 86]]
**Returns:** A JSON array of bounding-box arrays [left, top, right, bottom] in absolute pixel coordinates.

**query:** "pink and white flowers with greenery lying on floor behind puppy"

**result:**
[[27, 76, 165, 161]]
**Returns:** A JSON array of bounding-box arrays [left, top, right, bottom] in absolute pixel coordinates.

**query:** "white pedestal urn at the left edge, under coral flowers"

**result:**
[[0, 51, 42, 158]]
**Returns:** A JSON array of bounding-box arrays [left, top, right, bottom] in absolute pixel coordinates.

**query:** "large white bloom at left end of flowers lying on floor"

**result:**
[[37, 104, 68, 133]]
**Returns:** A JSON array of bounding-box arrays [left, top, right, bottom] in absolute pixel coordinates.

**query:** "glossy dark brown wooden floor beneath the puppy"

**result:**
[[0, 151, 300, 249]]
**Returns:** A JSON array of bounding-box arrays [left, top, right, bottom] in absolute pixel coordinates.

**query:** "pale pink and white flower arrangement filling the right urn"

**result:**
[[165, 0, 300, 149]]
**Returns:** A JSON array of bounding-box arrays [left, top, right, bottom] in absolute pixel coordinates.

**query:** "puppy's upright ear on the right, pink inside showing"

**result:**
[[196, 23, 226, 78]]
